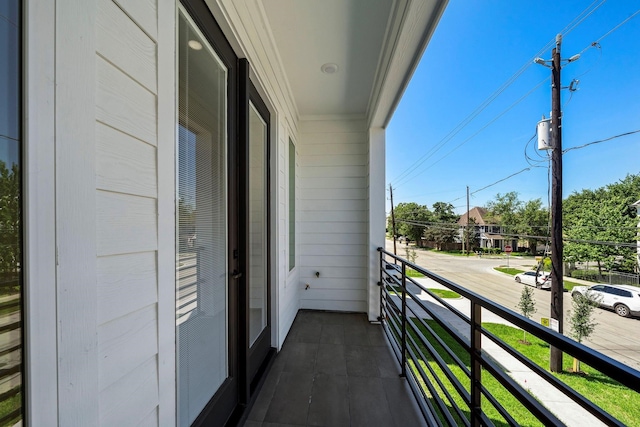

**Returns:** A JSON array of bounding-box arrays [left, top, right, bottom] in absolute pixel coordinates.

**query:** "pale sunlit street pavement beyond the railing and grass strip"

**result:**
[[387, 240, 640, 370]]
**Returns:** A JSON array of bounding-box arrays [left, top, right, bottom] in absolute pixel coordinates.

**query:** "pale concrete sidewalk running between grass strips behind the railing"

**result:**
[[392, 279, 605, 427]]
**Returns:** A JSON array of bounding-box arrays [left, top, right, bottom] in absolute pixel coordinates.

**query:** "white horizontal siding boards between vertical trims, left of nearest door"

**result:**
[[94, 0, 164, 425]]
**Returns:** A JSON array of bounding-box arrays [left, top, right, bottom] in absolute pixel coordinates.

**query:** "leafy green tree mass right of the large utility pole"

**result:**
[[563, 174, 640, 274]]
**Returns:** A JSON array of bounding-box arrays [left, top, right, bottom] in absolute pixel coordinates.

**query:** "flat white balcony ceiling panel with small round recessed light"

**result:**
[[263, 0, 396, 117]]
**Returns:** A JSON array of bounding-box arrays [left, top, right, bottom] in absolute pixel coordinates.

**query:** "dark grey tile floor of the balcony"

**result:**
[[244, 310, 425, 427]]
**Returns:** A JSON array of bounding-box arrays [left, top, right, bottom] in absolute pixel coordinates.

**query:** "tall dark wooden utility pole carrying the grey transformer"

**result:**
[[549, 34, 564, 372]]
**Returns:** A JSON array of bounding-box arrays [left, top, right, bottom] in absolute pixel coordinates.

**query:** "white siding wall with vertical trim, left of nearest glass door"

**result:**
[[56, 0, 175, 425]]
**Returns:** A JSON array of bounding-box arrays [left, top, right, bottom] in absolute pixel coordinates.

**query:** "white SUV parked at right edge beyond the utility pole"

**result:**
[[571, 284, 640, 317]]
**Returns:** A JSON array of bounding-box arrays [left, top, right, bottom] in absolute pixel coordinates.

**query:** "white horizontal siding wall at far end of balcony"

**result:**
[[298, 120, 369, 312]]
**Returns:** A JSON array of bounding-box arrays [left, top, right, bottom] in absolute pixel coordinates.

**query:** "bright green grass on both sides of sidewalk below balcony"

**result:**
[[410, 320, 640, 426]]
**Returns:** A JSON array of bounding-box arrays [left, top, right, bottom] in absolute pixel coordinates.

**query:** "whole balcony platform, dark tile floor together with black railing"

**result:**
[[244, 249, 640, 427]]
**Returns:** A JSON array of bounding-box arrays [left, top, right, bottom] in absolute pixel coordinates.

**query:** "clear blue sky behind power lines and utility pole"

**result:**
[[386, 0, 640, 213]]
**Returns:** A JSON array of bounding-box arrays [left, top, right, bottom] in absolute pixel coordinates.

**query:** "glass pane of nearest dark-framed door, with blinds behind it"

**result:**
[[176, 8, 230, 425]]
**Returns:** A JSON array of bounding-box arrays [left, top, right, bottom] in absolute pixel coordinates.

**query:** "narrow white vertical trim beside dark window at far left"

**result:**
[[22, 0, 58, 426]]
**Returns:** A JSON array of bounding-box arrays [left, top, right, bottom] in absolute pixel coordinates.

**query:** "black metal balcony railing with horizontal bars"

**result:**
[[378, 248, 640, 426]]
